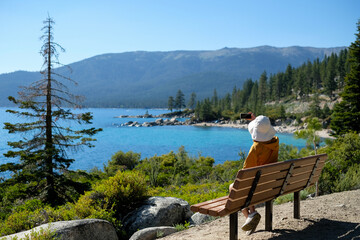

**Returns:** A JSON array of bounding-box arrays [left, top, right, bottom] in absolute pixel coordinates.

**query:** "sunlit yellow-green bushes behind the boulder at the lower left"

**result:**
[[0, 171, 147, 237]]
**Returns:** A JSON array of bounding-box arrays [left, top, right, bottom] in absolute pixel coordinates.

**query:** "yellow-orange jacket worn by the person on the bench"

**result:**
[[243, 137, 279, 169]]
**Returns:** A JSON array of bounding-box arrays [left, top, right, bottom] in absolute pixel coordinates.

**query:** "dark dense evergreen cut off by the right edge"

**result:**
[[331, 20, 360, 135]]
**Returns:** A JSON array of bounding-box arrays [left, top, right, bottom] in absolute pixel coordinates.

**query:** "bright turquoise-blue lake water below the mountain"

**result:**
[[0, 108, 305, 170]]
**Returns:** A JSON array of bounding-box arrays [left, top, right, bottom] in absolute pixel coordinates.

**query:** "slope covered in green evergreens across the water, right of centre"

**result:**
[[195, 49, 349, 121]]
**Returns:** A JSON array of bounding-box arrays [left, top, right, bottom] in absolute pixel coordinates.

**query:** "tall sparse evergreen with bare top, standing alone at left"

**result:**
[[0, 17, 101, 205]]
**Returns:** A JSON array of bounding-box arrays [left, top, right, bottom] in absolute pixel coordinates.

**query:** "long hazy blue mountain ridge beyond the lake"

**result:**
[[0, 46, 345, 107]]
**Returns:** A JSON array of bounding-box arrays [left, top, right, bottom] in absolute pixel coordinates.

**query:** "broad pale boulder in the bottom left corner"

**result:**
[[1, 219, 118, 240]]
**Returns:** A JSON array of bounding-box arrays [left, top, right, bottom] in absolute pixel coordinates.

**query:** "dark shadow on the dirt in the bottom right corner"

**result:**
[[260, 219, 360, 240]]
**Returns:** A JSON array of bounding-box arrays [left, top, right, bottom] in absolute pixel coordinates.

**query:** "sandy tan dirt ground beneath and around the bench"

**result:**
[[161, 189, 360, 240]]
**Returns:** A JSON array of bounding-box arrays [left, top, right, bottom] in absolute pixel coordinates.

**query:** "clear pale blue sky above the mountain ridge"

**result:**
[[0, 0, 360, 73]]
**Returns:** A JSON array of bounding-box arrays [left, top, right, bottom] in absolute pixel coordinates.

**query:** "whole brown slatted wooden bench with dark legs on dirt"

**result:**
[[190, 154, 327, 240]]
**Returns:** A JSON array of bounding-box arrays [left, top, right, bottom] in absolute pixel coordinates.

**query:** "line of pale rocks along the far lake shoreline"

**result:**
[[116, 114, 334, 139]]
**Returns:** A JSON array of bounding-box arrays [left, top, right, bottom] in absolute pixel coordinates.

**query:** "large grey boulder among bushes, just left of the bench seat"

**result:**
[[123, 197, 193, 235]]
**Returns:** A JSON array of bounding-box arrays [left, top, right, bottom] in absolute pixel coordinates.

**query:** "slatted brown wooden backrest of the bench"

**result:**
[[225, 154, 327, 212]]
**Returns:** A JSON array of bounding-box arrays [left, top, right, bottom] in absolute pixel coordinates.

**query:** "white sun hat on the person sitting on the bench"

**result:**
[[248, 115, 276, 142]]
